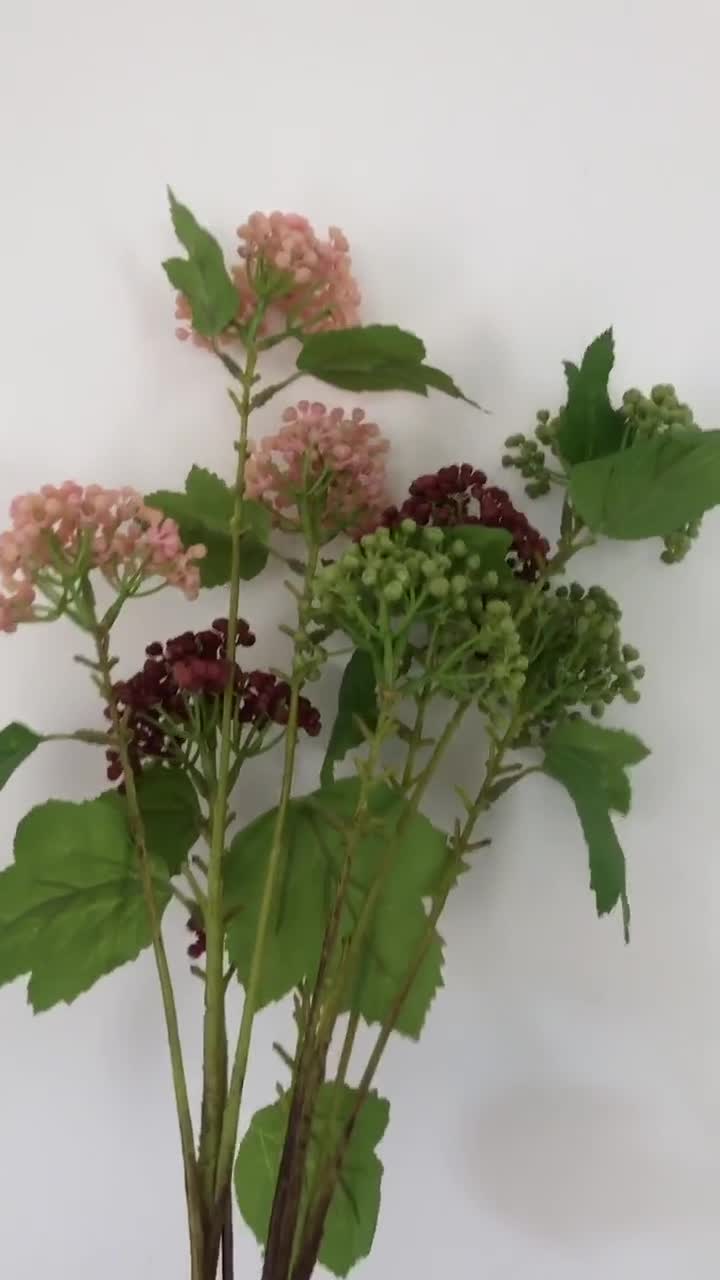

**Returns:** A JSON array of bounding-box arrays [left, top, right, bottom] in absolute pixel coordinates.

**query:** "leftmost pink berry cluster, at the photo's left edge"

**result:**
[[0, 480, 205, 631]]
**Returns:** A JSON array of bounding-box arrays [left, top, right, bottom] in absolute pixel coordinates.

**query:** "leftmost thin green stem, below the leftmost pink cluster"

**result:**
[[94, 622, 204, 1275]]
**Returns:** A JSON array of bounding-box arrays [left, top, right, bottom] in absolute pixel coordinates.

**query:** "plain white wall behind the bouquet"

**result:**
[[0, 0, 720, 1280]]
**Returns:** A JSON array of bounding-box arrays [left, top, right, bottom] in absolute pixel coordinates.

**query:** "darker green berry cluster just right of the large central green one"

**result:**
[[512, 582, 644, 740]]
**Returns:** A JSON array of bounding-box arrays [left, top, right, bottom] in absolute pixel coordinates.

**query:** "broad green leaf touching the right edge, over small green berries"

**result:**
[[568, 431, 720, 540]]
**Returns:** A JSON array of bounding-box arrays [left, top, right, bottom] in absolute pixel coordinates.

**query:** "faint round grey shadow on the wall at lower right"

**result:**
[[462, 1084, 720, 1245]]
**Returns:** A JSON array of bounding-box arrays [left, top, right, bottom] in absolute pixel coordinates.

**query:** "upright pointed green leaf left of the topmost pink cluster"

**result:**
[[163, 189, 238, 338]]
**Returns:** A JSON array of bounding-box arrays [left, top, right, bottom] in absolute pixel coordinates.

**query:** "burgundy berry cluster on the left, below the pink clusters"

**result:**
[[105, 618, 320, 782]]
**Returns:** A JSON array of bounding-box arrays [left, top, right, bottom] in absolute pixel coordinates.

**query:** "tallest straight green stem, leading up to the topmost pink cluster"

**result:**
[[200, 344, 258, 1206]]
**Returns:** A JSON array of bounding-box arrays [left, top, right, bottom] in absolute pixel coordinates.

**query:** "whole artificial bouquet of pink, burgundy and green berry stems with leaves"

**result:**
[[0, 193, 720, 1280]]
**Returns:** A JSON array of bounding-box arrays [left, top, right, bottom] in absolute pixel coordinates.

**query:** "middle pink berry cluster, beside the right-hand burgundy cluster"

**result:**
[[246, 401, 389, 532]]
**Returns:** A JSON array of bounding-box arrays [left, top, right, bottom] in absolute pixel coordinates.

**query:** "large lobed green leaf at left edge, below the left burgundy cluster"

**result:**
[[0, 795, 170, 1012]]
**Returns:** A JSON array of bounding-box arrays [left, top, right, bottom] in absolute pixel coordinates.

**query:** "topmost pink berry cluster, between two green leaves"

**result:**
[[176, 212, 360, 347]]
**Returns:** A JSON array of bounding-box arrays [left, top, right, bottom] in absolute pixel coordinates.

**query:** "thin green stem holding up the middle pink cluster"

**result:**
[[214, 540, 319, 1199]]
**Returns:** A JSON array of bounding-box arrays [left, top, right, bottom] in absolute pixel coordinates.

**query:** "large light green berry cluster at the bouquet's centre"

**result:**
[[314, 520, 529, 719]]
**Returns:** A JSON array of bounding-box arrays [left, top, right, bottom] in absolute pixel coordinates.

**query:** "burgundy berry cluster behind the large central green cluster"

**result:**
[[380, 462, 550, 579]]
